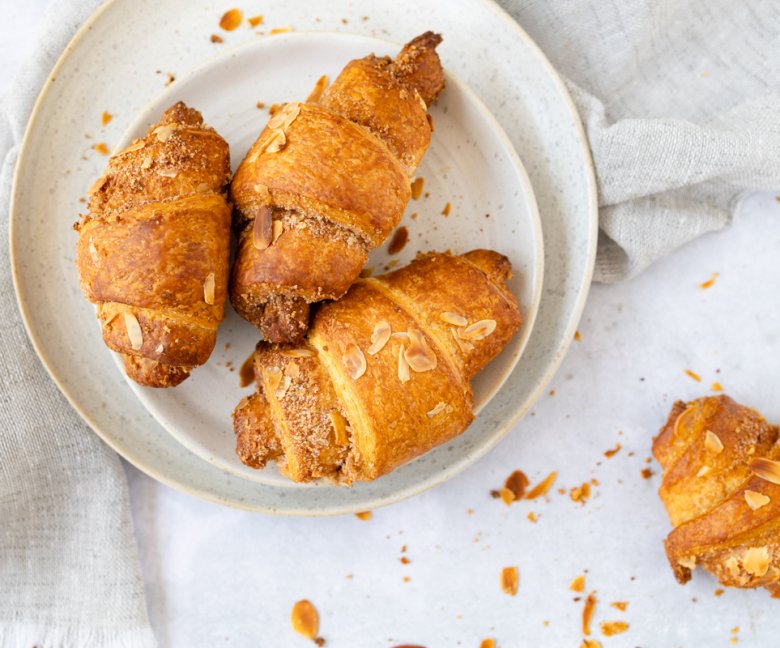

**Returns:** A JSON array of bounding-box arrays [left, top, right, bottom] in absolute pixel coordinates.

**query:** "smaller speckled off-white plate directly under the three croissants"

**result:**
[[115, 32, 544, 488]]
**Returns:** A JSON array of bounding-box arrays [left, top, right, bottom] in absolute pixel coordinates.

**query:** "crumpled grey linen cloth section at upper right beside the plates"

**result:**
[[501, 0, 780, 282]]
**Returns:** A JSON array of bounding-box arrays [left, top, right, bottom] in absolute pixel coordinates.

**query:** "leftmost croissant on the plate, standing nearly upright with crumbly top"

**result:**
[[74, 103, 231, 387]]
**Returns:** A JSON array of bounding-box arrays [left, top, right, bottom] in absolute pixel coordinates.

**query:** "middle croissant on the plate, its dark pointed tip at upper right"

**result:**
[[230, 32, 444, 342]]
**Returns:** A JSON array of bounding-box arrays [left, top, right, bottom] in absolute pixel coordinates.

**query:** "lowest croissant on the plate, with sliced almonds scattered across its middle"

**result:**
[[233, 250, 520, 484]]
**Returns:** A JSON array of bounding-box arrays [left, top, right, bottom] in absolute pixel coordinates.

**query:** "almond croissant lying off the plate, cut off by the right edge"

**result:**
[[653, 396, 780, 597]]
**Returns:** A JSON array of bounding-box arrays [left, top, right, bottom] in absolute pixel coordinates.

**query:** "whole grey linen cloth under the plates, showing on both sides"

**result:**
[[0, 0, 780, 648]]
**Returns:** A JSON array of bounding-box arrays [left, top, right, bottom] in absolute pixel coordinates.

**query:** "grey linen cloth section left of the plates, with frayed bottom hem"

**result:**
[[0, 0, 156, 648]]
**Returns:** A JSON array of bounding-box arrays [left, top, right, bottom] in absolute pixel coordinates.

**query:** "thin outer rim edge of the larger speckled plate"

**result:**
[[8, 0, 598, 516]]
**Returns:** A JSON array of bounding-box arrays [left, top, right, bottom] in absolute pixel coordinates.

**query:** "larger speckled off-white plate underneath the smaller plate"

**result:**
[[10, 0, 597, 514]]
